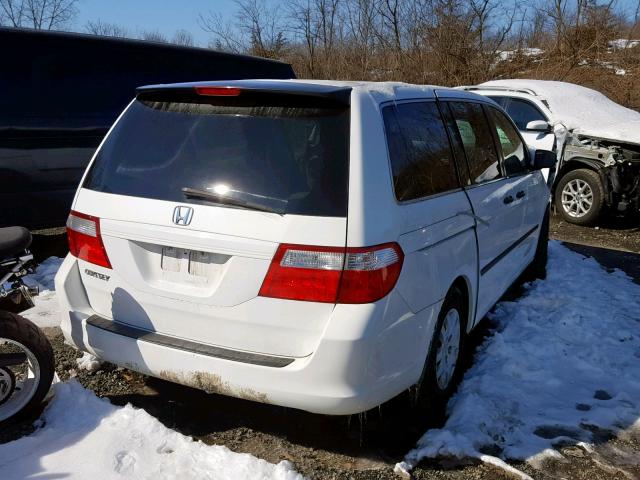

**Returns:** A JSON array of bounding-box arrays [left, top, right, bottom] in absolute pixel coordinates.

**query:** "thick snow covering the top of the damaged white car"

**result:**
[[480, 79, 640, 144]]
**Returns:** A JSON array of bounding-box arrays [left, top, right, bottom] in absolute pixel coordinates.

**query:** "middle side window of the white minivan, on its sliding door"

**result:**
[[449, 102, 501, 183]]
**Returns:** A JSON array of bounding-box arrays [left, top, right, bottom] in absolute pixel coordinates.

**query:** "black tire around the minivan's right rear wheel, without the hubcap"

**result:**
[[416, 286, 468, 419]]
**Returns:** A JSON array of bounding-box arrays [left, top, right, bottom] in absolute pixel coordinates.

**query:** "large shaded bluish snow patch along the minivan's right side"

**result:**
[[396, 242, 640, 478]]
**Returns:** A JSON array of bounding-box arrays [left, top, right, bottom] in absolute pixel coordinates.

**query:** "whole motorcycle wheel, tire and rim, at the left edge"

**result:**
[[0, 311, 54, 426]]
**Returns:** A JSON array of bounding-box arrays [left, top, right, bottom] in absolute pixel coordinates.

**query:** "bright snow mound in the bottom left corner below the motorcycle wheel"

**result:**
[[0, 380, 302, 480]]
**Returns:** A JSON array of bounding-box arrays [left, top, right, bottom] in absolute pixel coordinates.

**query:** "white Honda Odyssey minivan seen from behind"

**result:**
[[56, 80, 555, 414]]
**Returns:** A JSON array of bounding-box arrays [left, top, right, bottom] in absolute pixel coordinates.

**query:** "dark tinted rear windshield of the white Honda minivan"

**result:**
[[83, 99, 349, 217]]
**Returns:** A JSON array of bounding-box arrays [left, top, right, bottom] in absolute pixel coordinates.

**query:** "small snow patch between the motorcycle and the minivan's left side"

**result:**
[[21, 257, 64, 328]]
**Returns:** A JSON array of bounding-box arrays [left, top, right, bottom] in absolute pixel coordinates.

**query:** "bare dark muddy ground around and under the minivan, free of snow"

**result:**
[[0, 217, 640, 480]]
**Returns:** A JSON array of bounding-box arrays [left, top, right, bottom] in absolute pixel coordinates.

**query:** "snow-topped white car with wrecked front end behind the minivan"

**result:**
[[463, 80, 640, 225]]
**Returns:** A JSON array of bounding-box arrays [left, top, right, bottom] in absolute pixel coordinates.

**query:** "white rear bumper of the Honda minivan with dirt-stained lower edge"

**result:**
[[56, 256, 439, 415]]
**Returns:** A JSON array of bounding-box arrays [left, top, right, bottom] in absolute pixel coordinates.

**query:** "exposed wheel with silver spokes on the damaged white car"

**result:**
[[555, 168, 604, 225]]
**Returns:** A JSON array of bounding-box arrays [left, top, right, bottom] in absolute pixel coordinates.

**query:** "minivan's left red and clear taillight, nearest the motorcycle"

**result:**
[[67, 210, 111, 268]]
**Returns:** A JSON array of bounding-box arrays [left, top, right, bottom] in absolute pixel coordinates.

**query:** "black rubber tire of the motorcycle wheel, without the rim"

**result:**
[[0, 311, 55, 427]]
